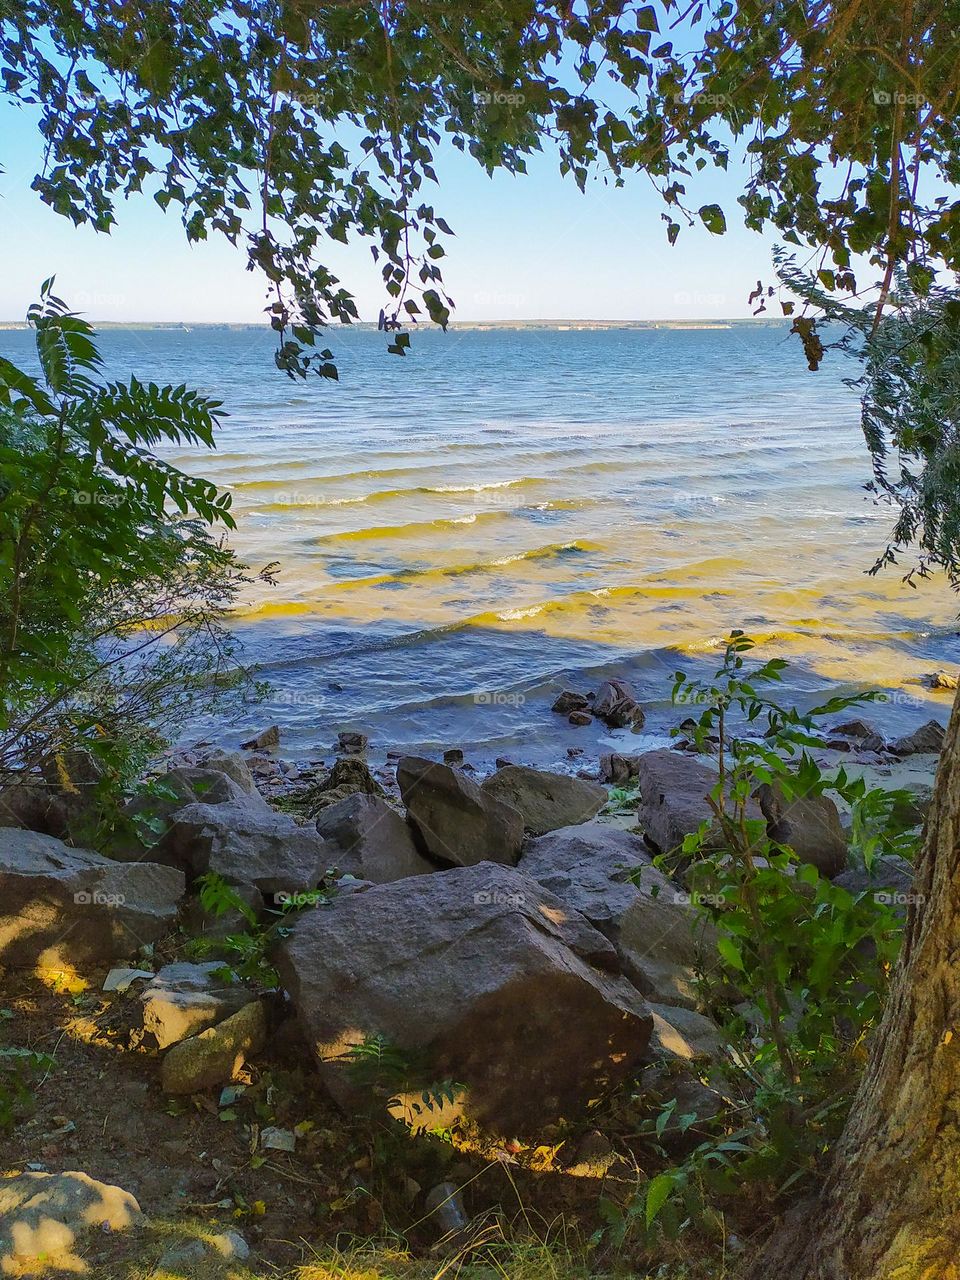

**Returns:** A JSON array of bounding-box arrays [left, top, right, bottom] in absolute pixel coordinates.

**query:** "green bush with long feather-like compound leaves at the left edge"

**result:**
[[0, 280, 263, 787]]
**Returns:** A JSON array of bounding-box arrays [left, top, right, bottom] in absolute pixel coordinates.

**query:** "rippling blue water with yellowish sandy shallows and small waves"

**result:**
[[0, 328, 960, 763]]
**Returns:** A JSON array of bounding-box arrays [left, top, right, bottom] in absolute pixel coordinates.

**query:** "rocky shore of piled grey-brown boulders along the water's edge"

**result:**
[[0, 681, 943, 1274]]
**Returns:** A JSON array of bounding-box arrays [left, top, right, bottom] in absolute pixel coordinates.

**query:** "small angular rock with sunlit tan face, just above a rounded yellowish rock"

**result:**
[[133, 960, 256, 1050]]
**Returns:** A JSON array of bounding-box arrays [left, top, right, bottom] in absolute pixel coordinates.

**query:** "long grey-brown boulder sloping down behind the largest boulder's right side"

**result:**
[[520, 822, 717, 1007]]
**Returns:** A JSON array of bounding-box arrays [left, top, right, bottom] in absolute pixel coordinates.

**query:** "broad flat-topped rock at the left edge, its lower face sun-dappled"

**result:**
[[0, 827, 186, 969]]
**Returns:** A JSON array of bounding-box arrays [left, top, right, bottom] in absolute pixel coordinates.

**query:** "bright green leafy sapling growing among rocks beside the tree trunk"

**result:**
[[604, 631, 918, 1239]]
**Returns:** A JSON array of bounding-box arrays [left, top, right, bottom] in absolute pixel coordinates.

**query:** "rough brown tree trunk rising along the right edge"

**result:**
[[751, 694, 960, 1280]]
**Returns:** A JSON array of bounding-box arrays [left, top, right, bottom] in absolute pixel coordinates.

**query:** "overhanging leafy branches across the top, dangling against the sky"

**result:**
[[0, 0, 960, 376]]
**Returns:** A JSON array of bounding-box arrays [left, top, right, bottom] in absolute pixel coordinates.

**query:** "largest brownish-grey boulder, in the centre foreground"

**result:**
[[278, 861, 652, 1133]]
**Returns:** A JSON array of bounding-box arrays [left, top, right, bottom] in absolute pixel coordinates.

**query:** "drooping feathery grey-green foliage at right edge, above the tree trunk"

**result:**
[[778, 255, 960, 589]]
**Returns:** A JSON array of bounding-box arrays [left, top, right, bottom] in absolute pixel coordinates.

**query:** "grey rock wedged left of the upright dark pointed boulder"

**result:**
[[316, 792, 436, 884]]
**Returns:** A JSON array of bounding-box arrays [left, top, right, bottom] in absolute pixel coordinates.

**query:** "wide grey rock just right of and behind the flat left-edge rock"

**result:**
[[159, 804, 328, 901]]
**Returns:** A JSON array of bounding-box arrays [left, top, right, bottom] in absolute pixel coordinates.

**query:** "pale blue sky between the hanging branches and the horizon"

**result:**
[[0, 95, 788, 324]]
